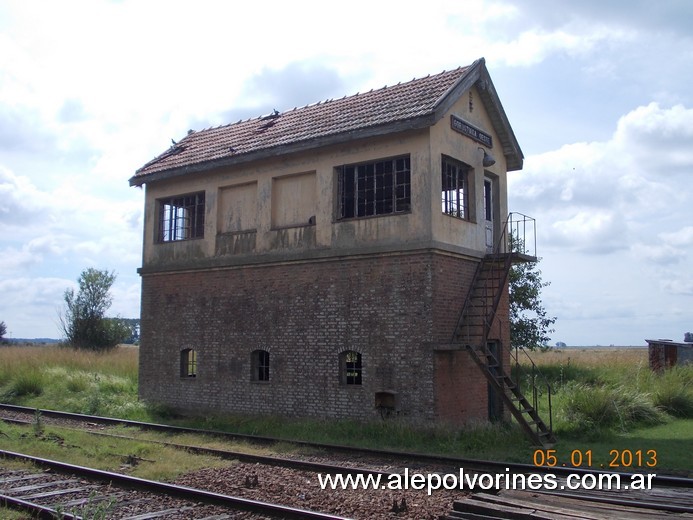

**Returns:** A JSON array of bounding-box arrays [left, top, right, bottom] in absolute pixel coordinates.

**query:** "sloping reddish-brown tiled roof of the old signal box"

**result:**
[[130, 61, 476, 184]]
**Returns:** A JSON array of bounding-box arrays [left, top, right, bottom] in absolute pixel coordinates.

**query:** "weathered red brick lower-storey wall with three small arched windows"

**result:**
[[140, 252, 486, 422]]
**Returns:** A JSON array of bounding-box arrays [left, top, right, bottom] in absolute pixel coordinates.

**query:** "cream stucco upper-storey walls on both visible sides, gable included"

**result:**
[[138, 82, 508, 272]]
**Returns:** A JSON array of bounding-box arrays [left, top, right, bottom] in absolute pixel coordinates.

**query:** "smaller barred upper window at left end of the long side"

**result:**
[[158, 191, 205, 242]]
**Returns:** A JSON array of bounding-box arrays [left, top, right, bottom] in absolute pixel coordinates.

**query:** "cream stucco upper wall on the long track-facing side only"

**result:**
[[143, 129, 439, 271]]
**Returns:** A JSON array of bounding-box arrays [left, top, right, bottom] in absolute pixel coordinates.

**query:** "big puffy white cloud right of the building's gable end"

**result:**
[[509, 103, 693, 252]]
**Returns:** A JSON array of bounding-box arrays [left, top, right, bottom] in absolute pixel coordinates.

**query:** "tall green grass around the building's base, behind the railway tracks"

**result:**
[[0, 346, 693, 474]]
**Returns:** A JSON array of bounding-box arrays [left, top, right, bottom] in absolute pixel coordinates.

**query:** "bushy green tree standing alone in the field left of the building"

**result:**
[[60, 267, 130, 350]]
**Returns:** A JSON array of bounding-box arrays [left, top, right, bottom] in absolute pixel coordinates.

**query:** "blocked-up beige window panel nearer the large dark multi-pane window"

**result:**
[[272, 172, 317, 228]]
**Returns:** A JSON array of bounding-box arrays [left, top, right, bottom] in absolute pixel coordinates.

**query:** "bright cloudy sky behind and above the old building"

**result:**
[[0, 0, 693, 345]]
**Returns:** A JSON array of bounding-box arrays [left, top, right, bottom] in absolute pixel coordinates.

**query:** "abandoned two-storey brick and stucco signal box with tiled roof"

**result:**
[[130, 59, 552, 442]]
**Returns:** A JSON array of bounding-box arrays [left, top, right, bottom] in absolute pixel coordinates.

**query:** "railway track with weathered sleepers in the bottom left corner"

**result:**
[[0, 450, 342, 520]]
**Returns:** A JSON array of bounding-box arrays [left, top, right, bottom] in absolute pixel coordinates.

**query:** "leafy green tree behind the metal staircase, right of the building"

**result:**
[[508, 239, 556, 350]]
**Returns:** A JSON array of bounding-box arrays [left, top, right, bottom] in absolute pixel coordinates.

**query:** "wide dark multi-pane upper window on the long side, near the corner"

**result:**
[[337, 155, 411, 219]]
